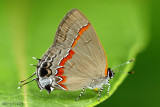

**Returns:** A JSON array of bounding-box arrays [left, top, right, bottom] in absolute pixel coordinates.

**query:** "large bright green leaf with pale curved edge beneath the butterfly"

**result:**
[[0, 0, 149, 107]]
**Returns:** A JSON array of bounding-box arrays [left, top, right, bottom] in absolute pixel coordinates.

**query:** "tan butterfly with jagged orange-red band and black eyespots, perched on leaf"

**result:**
[[18, 9, 132, 100]]
